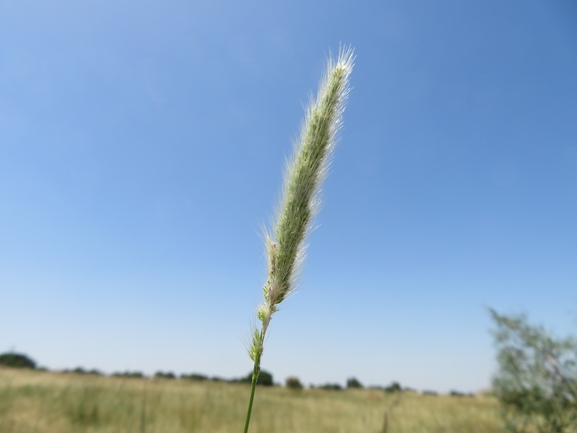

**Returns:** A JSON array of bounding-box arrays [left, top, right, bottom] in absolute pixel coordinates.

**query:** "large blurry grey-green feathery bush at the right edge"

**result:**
[[490, 310, 577, 433]]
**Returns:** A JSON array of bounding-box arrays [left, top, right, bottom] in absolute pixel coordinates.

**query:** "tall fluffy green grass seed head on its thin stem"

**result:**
[[244, 48, 354, 433]]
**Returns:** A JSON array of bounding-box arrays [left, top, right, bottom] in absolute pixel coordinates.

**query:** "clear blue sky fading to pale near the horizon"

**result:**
[[0, 0, 577, 391]]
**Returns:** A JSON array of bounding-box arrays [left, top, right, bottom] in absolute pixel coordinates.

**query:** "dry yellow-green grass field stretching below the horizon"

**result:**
[[0, 368, 503, 433]]
